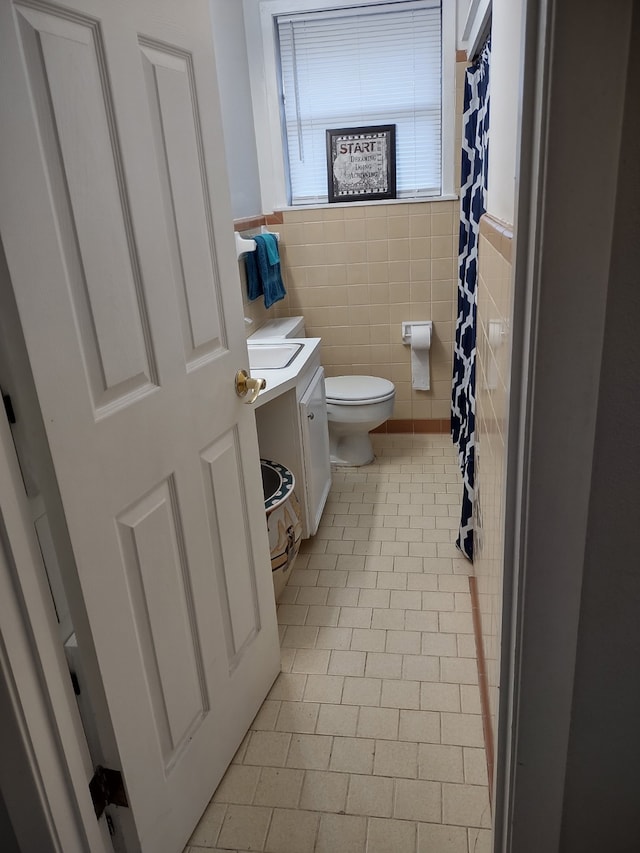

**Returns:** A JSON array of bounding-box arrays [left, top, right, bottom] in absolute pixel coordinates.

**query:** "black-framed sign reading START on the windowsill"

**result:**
[[327, 124, 396, 204]]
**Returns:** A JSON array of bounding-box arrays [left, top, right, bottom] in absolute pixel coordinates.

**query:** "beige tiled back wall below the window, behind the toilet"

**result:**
[[241, 56, 466, 420]]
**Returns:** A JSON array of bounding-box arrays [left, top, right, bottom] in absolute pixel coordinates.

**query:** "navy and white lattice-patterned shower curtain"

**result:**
[[451, 38, 491, 560]]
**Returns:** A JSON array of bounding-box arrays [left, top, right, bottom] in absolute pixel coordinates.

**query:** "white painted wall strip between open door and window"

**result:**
[[209, 0, 264, 219]]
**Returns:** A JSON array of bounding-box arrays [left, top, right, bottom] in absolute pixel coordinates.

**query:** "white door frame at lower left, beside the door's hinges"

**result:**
[[0, 406, 113, 853]]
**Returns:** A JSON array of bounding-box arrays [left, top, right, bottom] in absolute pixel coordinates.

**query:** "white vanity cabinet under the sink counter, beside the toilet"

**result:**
[[254, 348, 331, 539]]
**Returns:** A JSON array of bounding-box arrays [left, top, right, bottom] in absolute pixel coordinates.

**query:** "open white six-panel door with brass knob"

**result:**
[[0, 0, 279, 853]]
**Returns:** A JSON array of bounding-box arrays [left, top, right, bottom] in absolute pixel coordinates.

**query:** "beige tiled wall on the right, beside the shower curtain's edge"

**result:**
[[473, 217, 513, 776]]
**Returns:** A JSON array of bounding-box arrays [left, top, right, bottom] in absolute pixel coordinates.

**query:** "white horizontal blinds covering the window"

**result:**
[[277, 0, 442, 205]]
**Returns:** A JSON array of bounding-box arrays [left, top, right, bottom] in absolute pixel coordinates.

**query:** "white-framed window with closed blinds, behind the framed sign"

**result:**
[[244, 0, 458, 211]]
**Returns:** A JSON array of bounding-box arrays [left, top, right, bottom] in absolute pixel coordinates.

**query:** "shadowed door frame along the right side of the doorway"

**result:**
[[494, 0, 632, 853]]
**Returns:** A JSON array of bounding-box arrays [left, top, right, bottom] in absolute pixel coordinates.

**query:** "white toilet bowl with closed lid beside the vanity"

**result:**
[[325, 376, 396, 465]]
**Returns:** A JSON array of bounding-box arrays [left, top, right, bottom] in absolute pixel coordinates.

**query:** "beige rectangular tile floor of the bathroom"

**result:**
[[187, 435, 491, 853]]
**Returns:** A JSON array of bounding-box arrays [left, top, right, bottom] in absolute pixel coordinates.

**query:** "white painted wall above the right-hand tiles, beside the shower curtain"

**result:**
[[487, 0, 524, 225]]
